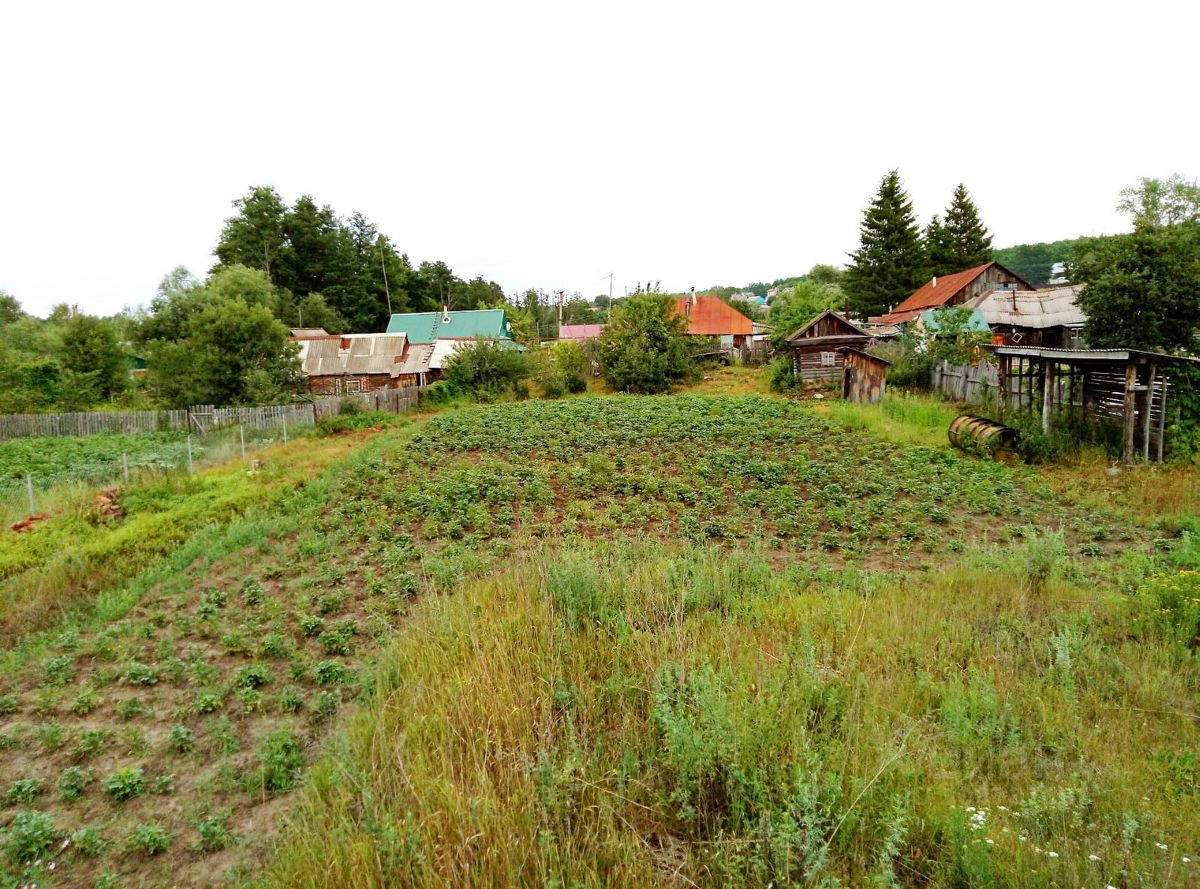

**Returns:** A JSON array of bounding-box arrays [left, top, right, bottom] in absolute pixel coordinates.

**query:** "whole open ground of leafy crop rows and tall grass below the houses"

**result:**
[[0, 391, 1200, 889]]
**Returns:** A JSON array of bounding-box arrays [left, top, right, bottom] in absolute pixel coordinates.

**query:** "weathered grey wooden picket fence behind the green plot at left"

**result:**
[[0, 386, 422, 440]]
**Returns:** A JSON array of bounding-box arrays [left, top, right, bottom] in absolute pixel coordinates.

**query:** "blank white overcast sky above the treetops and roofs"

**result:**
[[0, 0, 1200, 313]]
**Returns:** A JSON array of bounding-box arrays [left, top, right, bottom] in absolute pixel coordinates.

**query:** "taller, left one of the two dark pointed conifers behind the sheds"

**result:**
[[844, 170, 929, 317]]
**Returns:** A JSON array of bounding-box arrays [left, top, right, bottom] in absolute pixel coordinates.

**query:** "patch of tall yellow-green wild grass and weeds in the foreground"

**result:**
[[264, 545, 1200, 887]]
